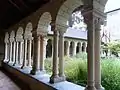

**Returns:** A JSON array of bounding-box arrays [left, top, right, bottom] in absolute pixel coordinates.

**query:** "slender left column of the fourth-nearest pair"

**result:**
[[21, 38, 28, 69]]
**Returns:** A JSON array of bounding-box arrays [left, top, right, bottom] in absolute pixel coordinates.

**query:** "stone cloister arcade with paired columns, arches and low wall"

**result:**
[[2, 0, 107, 90]]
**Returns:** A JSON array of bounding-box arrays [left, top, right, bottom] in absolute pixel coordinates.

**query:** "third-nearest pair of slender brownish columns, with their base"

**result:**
[[31, 35, 44, 75]]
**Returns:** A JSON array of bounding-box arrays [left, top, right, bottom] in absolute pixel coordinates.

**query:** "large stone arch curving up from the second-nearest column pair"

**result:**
[[56, 0, 83, 29]]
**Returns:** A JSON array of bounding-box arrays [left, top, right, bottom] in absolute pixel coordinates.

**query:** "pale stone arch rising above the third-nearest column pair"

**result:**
[[37, 12, 52, 33]]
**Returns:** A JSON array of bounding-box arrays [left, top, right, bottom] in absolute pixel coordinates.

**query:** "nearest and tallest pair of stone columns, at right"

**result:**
[[85, 14, 103, 90]]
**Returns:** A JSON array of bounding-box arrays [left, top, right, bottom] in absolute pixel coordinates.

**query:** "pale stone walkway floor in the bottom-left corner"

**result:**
[[0, 71, 21, 90]]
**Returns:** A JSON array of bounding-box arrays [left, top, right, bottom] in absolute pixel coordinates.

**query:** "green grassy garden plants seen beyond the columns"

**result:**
[[45, 53, 120, 90]]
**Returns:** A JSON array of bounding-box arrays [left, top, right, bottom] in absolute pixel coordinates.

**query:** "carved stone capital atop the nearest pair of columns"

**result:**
[[81, 6, 106, 28]]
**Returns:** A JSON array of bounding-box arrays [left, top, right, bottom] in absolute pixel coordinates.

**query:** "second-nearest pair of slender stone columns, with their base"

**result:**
[[50, 30, 65, 83]]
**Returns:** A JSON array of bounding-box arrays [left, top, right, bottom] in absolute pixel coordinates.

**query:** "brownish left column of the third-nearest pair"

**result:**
[[31, 35, 40, 75]]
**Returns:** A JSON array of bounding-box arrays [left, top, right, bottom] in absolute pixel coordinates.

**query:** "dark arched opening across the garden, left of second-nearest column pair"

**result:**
[[46, 39, 53, 58]]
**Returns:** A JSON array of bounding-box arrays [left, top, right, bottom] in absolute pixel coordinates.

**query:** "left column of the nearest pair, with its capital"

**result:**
[[82, 10, 96, 90]]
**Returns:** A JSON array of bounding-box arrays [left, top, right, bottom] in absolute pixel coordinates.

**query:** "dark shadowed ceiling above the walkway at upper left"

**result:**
[[0, 0, 50, 29]]
